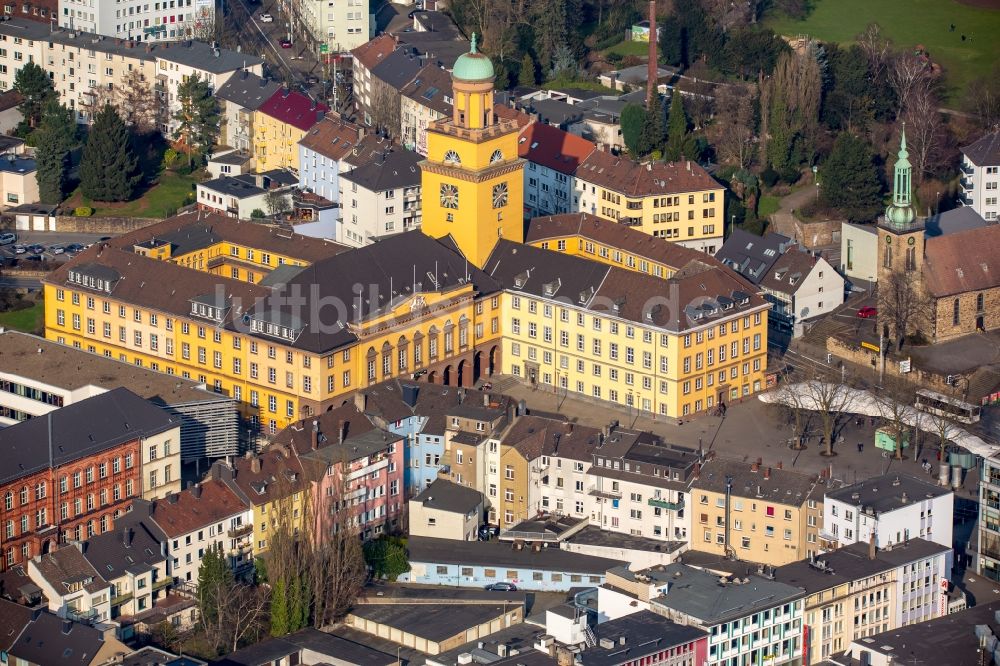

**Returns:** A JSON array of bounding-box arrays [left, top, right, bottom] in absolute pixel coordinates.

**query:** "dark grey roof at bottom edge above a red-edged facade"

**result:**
[[579, 610, 707, 666]]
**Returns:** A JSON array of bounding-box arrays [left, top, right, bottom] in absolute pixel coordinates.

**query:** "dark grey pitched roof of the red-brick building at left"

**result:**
[[0, 388, 180, 483]]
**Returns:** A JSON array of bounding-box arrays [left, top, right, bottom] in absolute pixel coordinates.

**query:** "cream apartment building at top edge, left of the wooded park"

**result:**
[[291, 0, 376, 54]]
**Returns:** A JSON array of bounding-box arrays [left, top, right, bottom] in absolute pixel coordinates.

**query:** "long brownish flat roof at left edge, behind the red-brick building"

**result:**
[[0, 331, 232, 406]]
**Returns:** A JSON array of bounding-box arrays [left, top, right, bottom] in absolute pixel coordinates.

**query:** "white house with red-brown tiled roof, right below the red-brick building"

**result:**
[[147, 478, 253, 587]]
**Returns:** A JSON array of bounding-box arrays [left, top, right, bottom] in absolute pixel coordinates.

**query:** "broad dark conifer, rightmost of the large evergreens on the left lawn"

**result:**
[[80, 104, 142, 201]]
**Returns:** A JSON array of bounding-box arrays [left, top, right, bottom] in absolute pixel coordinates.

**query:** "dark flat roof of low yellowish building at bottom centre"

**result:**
[[350, 603, 513, 642]]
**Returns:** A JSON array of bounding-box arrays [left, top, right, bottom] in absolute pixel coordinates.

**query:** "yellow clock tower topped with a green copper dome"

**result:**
[[420, 34, 524, 267]]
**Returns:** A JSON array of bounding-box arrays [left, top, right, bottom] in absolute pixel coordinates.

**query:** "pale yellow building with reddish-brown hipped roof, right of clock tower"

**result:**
[[573, 150, 725, 254]]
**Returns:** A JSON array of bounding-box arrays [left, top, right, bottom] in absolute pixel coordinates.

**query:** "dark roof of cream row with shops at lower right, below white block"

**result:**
[[774, 539, 951, 594]]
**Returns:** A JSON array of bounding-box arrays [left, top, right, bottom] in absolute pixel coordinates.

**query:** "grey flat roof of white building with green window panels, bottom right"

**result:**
[[648, 564, 805, 627]]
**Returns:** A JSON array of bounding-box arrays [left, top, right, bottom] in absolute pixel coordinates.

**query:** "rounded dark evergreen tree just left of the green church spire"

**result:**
[[819, 132, 882, 222]]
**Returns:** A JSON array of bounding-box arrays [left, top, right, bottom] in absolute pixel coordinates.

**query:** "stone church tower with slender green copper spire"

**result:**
[[878, 126, 924, 283]]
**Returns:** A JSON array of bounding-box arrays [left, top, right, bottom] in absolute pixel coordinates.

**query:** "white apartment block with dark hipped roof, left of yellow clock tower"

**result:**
[[340, 146, 422, 239]]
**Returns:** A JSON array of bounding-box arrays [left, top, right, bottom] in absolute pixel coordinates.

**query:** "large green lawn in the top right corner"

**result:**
[[765, 0, 1000, 102]]
